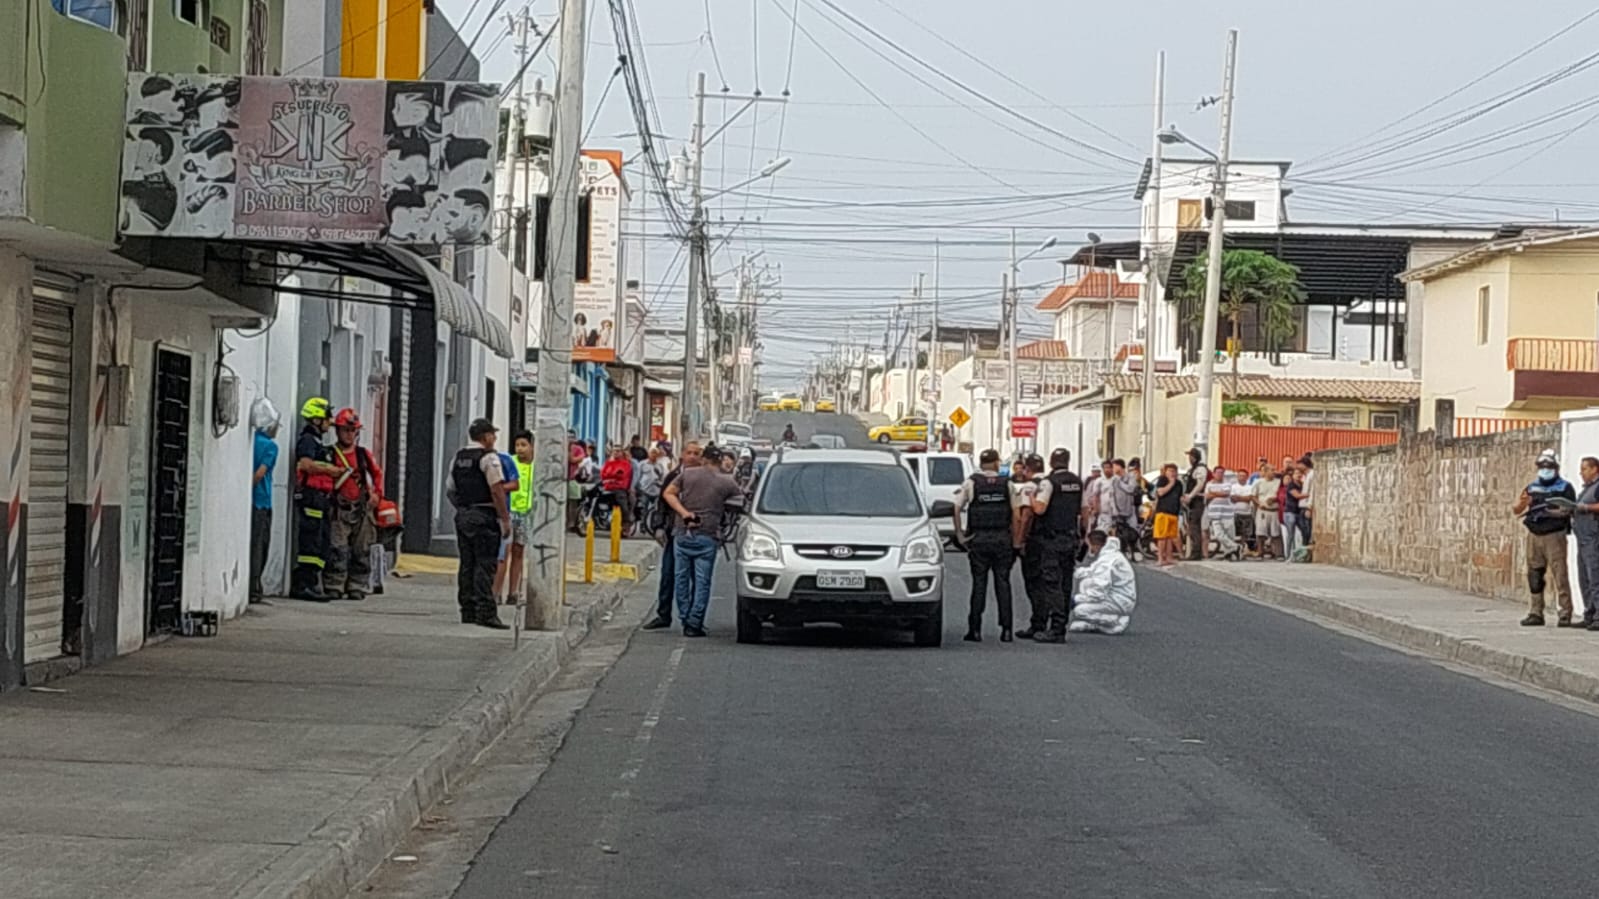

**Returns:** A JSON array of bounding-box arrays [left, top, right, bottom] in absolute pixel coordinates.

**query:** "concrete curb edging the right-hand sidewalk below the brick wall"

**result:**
[[1167, 566, 1599, 702]]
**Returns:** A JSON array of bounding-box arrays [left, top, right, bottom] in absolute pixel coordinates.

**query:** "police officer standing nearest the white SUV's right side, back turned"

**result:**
[[955, 450, 1015, 643]]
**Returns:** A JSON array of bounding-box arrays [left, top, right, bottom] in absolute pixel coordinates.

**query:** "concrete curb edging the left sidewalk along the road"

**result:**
[[235, 545, 660, 899]]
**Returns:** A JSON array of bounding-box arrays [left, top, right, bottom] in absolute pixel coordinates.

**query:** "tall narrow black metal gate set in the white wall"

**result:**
[[149, 349, 193, 633]]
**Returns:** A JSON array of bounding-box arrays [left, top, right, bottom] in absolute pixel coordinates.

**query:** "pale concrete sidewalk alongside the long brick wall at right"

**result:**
[[1169, 561, 1599, 702]]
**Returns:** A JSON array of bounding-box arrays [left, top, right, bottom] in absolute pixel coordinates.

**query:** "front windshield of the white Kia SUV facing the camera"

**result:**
[[758, 462, 921, 518]]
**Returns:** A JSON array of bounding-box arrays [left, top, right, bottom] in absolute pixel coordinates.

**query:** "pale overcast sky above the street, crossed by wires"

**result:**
[[440, 0, 1599, 387]]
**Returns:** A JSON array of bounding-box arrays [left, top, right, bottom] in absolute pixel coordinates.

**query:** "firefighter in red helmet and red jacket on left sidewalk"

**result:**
[[323, 410, 384, 600]]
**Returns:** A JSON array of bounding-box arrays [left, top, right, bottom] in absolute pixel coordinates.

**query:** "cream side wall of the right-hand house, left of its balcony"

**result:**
[[1420, 256, 1513, 430]]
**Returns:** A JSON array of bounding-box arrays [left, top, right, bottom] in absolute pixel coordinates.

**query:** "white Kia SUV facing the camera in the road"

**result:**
[[736, 450, 943, 646]]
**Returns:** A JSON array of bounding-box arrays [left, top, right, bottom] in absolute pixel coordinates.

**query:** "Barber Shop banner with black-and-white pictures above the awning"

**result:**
[[118, 72, 499, 245]]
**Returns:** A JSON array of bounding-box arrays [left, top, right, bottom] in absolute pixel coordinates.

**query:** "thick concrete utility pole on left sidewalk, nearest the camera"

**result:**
[[518, 0, 588, 630]]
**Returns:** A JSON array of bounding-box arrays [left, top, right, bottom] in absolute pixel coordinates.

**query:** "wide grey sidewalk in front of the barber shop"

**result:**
[[0, 541, 657, 899]]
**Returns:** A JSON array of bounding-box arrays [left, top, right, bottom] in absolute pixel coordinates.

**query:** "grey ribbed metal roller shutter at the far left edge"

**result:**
[[22, 298, 72, 662]]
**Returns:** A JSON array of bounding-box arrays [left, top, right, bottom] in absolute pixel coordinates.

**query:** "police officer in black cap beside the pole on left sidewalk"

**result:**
[[446, 418, 510, 630]]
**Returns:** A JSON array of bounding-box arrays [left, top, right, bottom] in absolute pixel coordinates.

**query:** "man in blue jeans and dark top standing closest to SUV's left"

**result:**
[[662, 443, 742, 637]]
